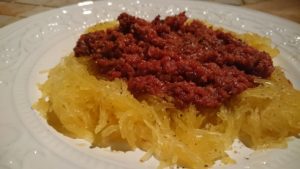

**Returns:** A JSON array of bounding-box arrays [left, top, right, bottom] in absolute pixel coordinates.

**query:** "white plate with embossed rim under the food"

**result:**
[[0, 0, 300, 169]]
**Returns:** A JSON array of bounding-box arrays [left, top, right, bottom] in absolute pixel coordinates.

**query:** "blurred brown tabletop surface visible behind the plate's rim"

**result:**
[[0, 0, 300, 28]]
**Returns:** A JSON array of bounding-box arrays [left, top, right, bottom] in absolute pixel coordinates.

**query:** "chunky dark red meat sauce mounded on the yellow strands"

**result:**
[[74, 13, 274, 108]]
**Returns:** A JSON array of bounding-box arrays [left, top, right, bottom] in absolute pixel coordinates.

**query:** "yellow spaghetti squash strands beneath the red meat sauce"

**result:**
[[33, 12, 300, 169]]
